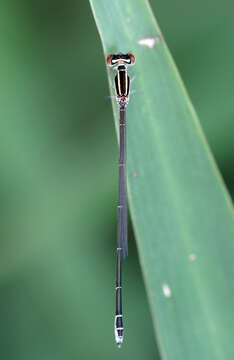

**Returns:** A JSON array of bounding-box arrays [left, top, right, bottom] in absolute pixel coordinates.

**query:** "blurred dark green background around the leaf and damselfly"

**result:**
[[0, 0, 234, 360]]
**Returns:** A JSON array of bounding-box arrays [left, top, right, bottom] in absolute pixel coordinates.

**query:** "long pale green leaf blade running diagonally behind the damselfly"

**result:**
[[90, 0, 234, 360]]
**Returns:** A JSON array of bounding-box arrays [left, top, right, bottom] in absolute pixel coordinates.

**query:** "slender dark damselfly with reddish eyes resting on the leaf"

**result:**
[[106, 53, 135, 347]]
